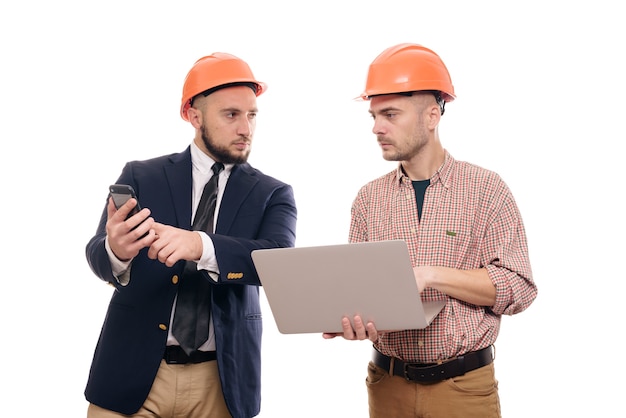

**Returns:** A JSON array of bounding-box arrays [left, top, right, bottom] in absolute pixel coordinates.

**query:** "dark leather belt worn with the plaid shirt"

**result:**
[[372, 345, 493, 382]]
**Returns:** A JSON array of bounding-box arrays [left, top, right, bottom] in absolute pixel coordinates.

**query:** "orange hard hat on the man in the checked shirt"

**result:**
[[359, 43, 456, 102]]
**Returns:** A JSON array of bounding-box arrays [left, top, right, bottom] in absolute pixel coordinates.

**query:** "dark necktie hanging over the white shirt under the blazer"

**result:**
[[172, 162, 224, 355]]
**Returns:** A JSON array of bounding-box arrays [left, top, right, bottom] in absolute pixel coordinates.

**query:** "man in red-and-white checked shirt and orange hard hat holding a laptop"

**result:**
[[324, 44, 537, 418]]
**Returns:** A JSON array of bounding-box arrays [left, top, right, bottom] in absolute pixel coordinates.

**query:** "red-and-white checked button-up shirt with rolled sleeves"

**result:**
[[349, 151, 537, 363]]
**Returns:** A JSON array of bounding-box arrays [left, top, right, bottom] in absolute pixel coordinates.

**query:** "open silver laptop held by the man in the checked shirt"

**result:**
[[252, 240, 445, 334]]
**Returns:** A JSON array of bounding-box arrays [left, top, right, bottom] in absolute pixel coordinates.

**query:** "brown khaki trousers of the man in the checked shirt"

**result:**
[[365, 362, 501, 418]]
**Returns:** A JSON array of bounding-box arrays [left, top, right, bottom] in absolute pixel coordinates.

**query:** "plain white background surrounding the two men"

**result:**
[[0, 0, 626, 418]]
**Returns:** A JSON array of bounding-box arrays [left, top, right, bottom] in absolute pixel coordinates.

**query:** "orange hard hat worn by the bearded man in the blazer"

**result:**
[[180, 52, 267, 121]]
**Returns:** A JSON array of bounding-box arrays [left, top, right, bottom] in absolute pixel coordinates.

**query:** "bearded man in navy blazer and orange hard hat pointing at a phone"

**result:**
[[85, 53, 296, 418]]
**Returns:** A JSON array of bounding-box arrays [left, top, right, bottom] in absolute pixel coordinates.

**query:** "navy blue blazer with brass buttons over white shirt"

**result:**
[[85, 148, 296, 418]]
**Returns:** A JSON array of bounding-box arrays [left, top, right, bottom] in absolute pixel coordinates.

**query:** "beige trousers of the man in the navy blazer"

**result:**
[[87, 360, 231, 418]]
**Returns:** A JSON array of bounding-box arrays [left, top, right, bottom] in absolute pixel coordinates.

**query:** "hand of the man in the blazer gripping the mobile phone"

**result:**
[[106, 198, 156, 261]]
